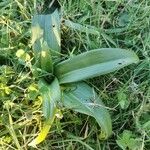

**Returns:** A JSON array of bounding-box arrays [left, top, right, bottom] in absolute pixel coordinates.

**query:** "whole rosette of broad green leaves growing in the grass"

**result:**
[[29, 5, 138, 146]]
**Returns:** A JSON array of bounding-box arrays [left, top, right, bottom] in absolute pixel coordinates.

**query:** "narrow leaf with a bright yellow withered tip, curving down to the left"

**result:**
[[29, 78, 61, 147]]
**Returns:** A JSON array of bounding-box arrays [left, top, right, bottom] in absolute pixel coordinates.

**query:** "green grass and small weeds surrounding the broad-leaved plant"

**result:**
[[0, 0, 150, 150]]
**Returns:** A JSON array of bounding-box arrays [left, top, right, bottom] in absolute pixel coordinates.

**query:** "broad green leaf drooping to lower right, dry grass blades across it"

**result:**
[[63, 82, 112, 139]]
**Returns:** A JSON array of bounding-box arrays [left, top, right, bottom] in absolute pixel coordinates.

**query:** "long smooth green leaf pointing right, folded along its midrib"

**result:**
[[55, 48, 139, 83]]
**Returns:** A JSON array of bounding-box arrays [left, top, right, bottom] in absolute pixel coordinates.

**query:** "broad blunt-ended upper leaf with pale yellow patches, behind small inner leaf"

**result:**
[[31, 9, 61, 63]]
